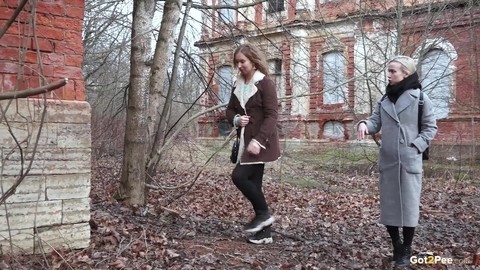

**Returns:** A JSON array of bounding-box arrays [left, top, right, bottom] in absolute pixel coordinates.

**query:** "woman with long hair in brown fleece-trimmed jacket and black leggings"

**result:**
[[226, 44, 280, 244]]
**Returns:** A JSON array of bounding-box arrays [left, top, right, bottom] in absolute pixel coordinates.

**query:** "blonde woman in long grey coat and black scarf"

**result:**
[[357, 56, 437, 266]]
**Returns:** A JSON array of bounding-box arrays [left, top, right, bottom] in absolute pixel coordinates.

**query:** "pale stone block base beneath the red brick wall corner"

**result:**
[[0, 99, 91, 254]]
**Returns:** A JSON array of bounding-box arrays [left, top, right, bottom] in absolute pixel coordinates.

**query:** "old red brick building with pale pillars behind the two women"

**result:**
[[196, 0, 480, 152]]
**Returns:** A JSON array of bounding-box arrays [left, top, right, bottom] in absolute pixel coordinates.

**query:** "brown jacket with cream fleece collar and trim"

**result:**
[[226, 71, 280, 164]]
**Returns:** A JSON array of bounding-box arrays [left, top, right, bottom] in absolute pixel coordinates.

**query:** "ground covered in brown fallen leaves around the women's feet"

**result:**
[[0, 151, 480, 270]]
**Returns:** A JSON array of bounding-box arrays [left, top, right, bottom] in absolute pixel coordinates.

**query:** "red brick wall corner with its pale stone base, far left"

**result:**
[[0, 0, 91, 253]]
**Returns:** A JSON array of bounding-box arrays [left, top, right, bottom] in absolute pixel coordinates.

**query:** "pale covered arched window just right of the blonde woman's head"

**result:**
[[420, 49, 453, 119]]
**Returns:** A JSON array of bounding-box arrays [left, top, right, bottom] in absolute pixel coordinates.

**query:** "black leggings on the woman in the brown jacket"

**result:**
[[232, 164, 268, 215]]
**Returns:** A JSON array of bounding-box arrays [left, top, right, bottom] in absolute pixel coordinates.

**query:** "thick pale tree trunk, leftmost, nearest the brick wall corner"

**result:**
[[117, 0, 155, 206]]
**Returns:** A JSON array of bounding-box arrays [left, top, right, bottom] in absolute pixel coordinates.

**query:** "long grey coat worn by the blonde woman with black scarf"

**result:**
[[364, 89, 437, 227]]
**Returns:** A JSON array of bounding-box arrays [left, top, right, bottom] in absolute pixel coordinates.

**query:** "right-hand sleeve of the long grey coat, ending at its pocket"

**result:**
[[412, 93, 437, 152]]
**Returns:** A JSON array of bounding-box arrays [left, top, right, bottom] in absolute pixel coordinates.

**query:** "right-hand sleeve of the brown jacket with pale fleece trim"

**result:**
[[253, 78, 278, 146]]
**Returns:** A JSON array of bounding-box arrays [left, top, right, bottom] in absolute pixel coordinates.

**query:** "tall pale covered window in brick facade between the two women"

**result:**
[[323, 51, 347, 104]]
